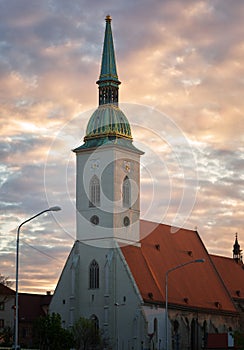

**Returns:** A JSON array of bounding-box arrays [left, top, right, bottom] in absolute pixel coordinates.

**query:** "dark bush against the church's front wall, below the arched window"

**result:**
[[72, 317, 102, 350]]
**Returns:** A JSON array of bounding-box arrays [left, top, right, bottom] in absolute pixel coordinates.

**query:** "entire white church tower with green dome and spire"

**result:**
[[74, 16, 143, 247]]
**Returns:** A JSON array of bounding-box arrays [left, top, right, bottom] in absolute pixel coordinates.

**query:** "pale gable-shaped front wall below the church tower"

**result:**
[[50, 241, 148, 350]]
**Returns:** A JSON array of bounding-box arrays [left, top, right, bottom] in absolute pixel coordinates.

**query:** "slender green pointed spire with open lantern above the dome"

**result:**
[[97, 15, 120, 106]]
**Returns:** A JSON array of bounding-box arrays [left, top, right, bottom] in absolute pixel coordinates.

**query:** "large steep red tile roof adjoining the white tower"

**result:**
[[121, 220, 236, 313]]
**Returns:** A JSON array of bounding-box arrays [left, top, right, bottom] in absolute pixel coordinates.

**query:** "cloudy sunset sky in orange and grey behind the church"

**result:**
[[0, 0, 244, 293]]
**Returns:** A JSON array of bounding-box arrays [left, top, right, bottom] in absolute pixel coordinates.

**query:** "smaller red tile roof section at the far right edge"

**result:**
[[210, 255, 244, 299]]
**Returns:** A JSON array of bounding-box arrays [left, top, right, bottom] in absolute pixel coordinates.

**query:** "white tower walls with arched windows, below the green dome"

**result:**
[[76, 147, 140, 247]]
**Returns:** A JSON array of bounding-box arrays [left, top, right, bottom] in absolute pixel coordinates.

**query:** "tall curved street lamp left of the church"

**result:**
[[14, 206, 61, 350]]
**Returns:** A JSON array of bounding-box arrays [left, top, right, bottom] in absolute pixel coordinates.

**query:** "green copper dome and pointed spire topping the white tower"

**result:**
[[74, 16, 143, 154]]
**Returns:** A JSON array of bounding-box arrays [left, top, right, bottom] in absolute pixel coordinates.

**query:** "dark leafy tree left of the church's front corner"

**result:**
[[35, 313, 73, 350]]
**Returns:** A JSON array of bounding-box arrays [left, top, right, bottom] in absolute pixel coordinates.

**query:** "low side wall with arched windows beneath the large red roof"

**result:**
[[138, 305, 238, 350]]
